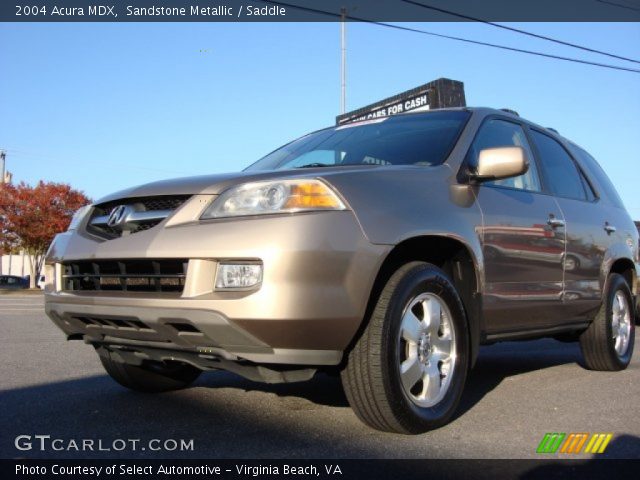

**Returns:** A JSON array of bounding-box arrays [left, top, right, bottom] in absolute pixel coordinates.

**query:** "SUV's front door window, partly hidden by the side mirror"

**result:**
[[467, 119, 542, 192]]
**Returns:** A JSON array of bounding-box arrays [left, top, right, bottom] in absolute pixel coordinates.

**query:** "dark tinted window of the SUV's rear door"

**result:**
[[531, 130, 587, 200]]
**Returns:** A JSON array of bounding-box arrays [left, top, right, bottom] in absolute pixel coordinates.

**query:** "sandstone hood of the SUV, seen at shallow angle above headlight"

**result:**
[[96, 165, 381, 204]]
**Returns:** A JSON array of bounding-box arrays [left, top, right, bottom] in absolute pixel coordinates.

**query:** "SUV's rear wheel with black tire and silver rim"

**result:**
[[580, 273, 635, 371]]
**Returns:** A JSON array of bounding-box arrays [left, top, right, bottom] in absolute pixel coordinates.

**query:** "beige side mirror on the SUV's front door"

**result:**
[[470, 147, 529, 182]]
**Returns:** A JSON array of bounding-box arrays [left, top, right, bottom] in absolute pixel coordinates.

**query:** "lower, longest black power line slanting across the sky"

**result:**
[[260, 0, 640, 73]]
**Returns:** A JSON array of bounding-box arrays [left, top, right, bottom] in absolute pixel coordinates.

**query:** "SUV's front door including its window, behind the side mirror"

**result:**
[[467, 117, 565, 335]]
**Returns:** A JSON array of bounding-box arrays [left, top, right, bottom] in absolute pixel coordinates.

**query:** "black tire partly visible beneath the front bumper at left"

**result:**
[[99, 351, 202, 393]]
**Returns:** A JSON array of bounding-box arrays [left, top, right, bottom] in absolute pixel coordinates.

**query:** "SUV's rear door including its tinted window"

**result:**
[[530, 129, 615, 323]]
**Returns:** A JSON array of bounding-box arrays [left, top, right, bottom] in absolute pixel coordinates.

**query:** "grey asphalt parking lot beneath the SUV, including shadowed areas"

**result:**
[[0, 294, 640, 458]]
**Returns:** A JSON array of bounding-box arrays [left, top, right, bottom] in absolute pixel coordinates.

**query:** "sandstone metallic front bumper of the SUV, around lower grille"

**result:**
[[45, 211, 390, 365]]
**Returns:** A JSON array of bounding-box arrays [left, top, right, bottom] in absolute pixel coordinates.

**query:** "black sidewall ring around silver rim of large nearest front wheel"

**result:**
[[381, 264, 469, 432]]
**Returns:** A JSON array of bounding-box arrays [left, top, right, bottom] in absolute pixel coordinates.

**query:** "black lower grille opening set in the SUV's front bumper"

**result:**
[[62, 259, 188, 293]]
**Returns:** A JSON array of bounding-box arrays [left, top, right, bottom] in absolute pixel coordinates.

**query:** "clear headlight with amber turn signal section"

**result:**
[[201, 179, 346, 219]]
